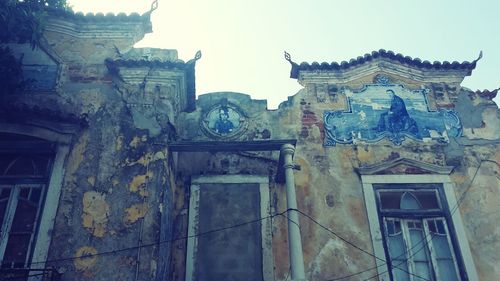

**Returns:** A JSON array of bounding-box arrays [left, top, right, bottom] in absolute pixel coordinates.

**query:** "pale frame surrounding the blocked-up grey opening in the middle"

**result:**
[[185, 175, 274, 281]]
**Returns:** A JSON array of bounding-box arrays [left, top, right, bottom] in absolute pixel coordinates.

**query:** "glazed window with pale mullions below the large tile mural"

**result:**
[[373, 184, 461, 281]]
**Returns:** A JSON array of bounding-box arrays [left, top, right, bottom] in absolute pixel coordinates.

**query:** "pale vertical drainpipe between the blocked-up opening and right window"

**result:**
[[281, 144, 307, 281]]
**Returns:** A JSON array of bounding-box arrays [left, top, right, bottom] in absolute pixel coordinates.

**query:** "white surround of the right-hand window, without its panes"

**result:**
[[361, 173, 478, 281]]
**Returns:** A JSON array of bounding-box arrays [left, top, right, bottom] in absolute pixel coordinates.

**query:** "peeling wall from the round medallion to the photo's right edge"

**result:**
[[173, 68, 500, 280]]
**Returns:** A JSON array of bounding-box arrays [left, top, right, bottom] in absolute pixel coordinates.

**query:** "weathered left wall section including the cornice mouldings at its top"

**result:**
[[0, 14, 185, 280]]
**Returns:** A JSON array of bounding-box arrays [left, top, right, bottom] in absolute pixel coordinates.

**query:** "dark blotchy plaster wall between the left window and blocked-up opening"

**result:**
[[41, 77, 176, 280]]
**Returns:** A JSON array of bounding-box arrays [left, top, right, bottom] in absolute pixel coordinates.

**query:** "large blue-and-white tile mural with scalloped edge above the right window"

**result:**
[[323, 79, 462, 146]]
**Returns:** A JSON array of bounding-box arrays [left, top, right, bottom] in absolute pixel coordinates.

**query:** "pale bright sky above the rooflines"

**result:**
[[68, 0, 500, 108]]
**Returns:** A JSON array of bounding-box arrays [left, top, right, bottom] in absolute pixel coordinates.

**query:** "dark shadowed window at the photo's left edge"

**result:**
[[0, 133, 54, 270]]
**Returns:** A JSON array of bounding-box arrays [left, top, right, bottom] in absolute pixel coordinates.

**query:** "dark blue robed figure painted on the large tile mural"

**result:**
[[377, 89, 418, 135]]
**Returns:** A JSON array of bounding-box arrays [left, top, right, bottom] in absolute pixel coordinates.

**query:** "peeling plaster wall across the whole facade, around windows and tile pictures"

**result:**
[[1, 13, 500, 281]]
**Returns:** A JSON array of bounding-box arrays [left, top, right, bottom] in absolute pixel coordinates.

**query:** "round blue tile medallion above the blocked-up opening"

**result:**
[[201, 104, 247, 139]]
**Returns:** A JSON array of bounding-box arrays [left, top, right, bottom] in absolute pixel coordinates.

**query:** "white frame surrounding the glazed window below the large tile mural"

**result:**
[[361, 174, 479, 281]]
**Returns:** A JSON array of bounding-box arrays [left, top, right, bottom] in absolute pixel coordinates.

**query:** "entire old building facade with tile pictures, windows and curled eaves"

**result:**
[[0, 7, 500, 281]]
